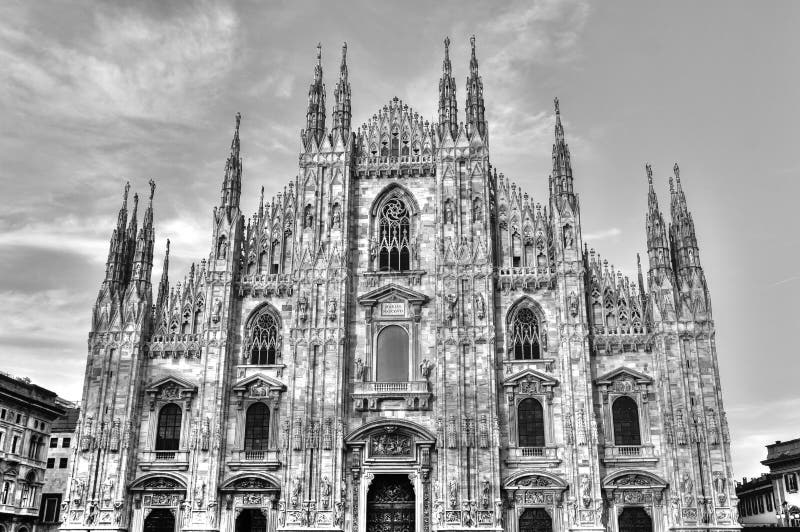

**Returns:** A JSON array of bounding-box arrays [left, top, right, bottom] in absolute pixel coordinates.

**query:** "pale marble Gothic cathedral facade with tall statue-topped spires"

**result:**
[[61, 38, 738, 532]]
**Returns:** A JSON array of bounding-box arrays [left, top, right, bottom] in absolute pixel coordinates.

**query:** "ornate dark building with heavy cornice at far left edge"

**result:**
[[0, 373, 65, 532]]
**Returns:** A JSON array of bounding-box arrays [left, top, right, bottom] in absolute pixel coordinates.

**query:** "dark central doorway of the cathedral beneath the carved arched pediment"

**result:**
[[367, 475, 415, 532]]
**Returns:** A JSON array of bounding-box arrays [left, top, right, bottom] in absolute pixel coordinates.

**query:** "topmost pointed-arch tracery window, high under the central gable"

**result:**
[[378, 198, 411, 272]]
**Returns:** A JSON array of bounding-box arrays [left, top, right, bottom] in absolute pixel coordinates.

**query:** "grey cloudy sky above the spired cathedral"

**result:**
[[0, 0, 800, 476]]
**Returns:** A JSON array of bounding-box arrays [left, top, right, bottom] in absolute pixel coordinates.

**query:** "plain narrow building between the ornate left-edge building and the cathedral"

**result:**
[[39, 399, 80, 530]]
